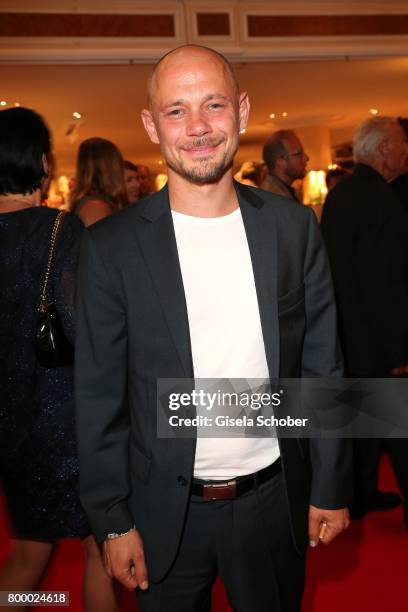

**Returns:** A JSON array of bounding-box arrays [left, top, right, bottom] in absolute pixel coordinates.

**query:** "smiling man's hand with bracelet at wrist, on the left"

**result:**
[[103, 529, 149, 591]]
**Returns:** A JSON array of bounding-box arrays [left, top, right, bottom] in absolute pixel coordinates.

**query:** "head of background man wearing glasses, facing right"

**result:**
[[263, 130, 309, 185]]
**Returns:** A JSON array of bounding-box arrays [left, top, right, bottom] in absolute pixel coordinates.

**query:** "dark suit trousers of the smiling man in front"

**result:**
[[138, 474, 305, 612]]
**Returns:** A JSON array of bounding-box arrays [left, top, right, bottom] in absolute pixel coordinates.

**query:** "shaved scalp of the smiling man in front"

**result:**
[[147, 45, 239, 110]]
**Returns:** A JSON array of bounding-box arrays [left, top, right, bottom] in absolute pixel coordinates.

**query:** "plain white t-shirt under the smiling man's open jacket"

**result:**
[[172, 208, 279, 480]]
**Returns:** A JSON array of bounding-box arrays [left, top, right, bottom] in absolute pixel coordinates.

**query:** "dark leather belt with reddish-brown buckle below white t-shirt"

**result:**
[[191, 457, 282, 501]]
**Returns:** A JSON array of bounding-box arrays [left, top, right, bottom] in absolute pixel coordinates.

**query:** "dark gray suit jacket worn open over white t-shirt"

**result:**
[[76, 183, 351, 581]]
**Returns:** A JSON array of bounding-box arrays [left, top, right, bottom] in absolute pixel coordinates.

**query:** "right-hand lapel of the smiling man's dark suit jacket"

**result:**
[[234, 182, 279, 378]]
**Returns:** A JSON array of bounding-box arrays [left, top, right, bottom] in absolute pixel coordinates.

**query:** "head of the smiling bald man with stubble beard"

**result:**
[[142, 45, 249, 184]]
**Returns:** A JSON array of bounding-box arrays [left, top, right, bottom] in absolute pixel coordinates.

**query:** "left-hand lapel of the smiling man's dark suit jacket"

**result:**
[[138, 187, 194, 378]]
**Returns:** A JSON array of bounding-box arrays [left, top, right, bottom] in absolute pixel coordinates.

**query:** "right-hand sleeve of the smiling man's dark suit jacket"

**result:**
[[302, 212, 353, 509]]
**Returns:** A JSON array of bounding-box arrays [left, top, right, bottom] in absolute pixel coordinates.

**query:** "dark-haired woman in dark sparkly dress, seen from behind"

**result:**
[[0, 108, 117, 612]]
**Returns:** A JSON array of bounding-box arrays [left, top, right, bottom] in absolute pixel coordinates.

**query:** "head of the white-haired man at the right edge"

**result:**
[[354, 117, 408, 181]]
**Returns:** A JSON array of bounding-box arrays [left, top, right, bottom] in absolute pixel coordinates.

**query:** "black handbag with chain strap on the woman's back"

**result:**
[[35, 211, 74, 368]]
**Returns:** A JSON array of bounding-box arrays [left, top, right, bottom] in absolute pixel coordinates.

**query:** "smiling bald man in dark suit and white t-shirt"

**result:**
[[76, 46, 350, 612]]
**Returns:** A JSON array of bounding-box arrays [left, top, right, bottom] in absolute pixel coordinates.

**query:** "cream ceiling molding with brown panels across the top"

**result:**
[[0, 0, 408, 65]]
